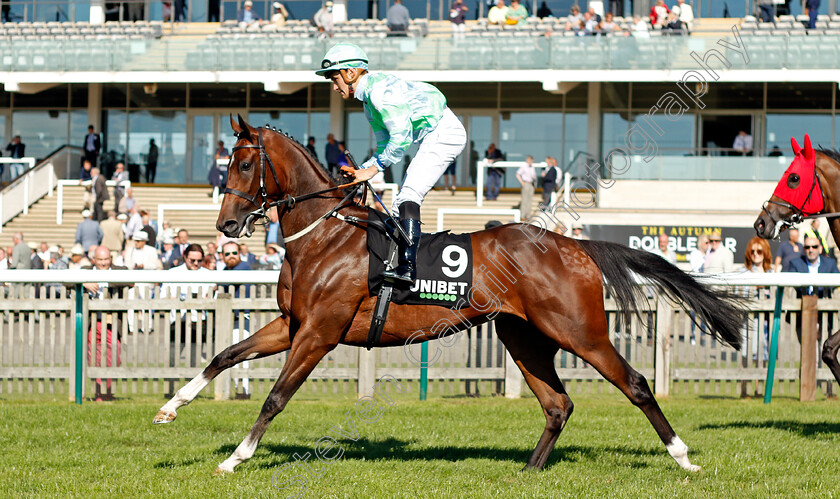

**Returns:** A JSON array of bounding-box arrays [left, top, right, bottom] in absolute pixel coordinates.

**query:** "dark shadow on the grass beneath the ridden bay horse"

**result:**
[[225, 437, 662, 468]]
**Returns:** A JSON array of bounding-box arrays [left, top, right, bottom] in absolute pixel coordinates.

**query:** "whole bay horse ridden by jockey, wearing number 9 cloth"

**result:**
[[155, 116, 745, 473]]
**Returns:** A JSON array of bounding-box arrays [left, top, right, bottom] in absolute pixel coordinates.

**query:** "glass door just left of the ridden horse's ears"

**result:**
[[185, 110, 236, 185]]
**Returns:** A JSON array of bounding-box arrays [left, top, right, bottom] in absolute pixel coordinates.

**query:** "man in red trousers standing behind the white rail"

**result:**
[[83, 246, 130, 402]]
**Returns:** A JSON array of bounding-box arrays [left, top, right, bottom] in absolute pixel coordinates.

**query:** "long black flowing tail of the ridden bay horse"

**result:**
[[578, 241, 746, 350]]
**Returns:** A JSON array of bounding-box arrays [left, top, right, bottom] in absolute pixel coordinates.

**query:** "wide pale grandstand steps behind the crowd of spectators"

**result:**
[[0, 186, 576, 255]]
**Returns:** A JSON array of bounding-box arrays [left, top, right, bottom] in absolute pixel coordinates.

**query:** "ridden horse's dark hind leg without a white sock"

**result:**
[[496, 317, 574, 470]]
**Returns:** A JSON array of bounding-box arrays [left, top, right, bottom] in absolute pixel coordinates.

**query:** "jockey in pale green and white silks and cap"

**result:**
[[315, 43, 467, 282]]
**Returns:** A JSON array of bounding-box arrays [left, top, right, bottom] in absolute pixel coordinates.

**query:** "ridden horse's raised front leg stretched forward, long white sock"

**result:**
[[152, 316, 291, 424]]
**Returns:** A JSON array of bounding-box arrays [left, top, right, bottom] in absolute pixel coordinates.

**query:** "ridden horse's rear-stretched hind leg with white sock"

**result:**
[[564, 316, 700, 471]]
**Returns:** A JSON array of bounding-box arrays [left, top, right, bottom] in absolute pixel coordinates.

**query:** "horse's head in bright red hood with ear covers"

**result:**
[[753, 135, 830, 239]]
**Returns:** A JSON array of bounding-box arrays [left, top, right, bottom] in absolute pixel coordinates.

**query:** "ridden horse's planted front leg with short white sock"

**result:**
[[214, 334, 337, 474]]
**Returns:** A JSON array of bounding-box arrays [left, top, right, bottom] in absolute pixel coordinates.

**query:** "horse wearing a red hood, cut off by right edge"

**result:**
[[754, 135, 840, 390]]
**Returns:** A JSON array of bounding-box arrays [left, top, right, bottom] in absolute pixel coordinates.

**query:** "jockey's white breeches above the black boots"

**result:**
[[392, 107, 467, 213]]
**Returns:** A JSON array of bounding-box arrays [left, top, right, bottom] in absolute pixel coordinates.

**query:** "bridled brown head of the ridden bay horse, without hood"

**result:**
[[216, 116, 290, 237]]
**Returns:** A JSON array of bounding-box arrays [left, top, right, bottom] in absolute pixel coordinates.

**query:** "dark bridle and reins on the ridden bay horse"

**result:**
[[222, 128, 360, 242]]
